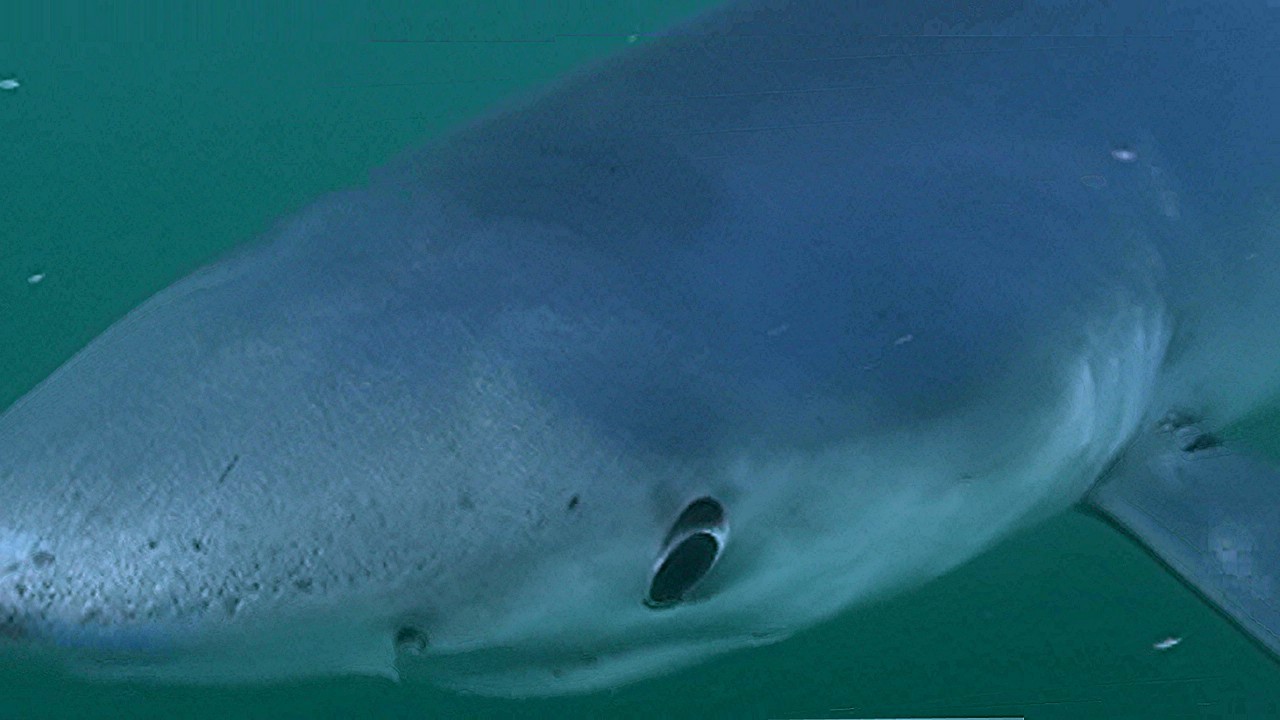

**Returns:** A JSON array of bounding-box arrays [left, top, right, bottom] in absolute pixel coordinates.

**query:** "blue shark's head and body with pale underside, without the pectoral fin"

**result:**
[[0, 0, 1280, 696]]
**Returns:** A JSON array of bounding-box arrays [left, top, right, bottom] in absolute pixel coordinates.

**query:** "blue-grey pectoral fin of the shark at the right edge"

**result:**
[[1085, 418, 1280, 655]]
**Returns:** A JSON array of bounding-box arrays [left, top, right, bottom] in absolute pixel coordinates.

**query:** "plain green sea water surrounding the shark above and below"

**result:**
[[0, 0, 1280, 719]]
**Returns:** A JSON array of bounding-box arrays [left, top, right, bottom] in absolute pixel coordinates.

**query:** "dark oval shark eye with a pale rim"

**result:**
[[644, 497, 728, 607]]
